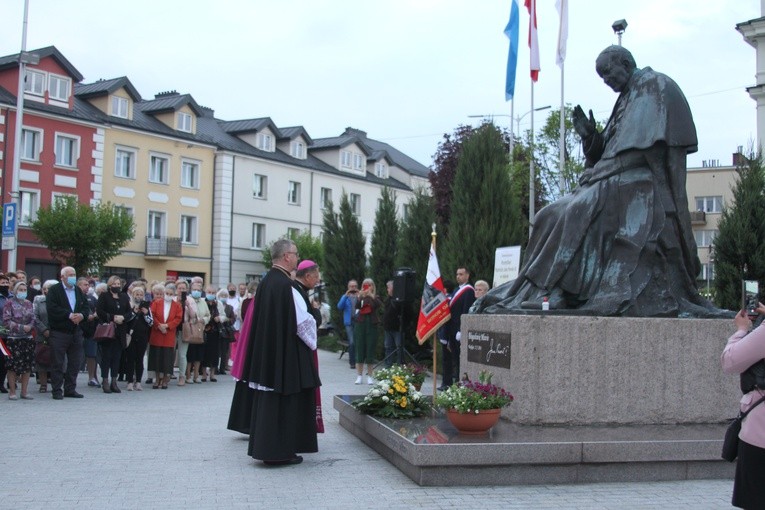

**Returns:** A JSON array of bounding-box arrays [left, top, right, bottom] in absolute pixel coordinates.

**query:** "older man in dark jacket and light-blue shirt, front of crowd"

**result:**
[[45, 266, 90, 400]]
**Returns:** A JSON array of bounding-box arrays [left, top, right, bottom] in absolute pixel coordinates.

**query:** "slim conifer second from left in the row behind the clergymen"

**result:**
[[369, 186, 399, 290]]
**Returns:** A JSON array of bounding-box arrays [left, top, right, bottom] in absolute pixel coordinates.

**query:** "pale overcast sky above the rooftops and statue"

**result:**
[[0, 0, 761, 166]]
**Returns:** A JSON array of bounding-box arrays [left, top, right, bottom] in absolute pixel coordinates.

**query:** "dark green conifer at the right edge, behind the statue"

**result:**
[[713, 154, 765, 310]]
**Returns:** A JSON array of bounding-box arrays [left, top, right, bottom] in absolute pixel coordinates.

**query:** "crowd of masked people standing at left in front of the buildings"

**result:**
[[0, 267, 256, 400]]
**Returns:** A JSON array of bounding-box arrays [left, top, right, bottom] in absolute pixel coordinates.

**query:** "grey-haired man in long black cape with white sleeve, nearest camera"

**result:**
[[233, 239, 321, 466]]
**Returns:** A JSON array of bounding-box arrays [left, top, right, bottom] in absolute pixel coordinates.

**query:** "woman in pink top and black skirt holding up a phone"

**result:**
[[721, 303, 765, 508]]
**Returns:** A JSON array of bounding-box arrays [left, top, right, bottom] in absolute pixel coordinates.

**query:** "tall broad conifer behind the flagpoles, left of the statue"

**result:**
[[439, 123, 524, 281]]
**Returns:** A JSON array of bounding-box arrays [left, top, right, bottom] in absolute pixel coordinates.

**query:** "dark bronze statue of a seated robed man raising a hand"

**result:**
[[473, 46, 726, 317]]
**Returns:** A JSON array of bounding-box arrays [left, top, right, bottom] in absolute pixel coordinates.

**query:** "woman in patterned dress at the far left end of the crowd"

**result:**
[[3, 280, 37, 400]]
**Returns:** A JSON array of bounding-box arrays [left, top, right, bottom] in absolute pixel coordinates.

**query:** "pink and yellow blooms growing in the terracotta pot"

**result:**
[[436, 370, 513, 414]]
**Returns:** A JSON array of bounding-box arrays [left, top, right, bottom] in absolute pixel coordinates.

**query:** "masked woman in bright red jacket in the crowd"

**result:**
[[149, 284, 183, 390]]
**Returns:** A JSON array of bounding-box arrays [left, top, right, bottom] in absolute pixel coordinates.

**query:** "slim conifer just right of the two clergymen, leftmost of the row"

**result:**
[[322, 192, 367, 329]]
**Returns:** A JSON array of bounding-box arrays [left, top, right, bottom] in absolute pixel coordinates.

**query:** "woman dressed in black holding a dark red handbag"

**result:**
[[95, 276, 134, 393]]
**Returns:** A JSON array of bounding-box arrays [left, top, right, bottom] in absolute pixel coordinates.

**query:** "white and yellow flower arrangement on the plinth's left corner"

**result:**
[[351, 365, 429, 418]]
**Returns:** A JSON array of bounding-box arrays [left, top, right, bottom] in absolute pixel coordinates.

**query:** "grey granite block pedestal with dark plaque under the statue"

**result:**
[[461, 314, 741, 425]]
